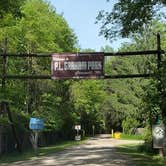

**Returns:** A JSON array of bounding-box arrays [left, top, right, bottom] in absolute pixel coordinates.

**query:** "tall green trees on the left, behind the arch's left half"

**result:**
[[0, 0, 77, 145]]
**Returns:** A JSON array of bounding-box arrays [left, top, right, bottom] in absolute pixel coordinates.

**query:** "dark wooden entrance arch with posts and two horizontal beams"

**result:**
[[0, 33, 165, 153]]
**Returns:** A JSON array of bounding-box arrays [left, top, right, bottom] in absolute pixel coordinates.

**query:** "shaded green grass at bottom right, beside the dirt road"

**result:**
[[117, 145, 166, 166]]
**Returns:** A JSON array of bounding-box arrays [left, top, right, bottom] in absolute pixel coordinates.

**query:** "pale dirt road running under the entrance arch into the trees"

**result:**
[[2, 135, 144, 166]]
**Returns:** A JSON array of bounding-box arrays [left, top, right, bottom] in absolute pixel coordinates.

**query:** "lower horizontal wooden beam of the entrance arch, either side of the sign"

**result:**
[[1, 74, 155, 80]]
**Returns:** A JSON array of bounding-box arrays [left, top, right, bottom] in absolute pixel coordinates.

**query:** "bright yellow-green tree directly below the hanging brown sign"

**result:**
[[71, 80, 105, 133]]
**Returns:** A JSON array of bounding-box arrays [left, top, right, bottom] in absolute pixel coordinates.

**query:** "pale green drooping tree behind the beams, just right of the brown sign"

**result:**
[[103, 57, 148, 130]]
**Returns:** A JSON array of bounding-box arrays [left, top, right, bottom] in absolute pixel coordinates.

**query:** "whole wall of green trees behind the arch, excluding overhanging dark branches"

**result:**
[[0, 0, 166, 154]]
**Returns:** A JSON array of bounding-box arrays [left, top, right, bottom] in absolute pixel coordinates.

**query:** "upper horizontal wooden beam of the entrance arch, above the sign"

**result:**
[[0, 50, 165, 58]]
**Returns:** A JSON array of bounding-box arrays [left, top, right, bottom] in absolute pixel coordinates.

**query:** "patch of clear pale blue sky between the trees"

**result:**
[[50, 0, 127, 51]]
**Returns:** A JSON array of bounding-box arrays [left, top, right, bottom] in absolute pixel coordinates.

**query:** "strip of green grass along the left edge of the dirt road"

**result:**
[[0, 140, 84, 163]]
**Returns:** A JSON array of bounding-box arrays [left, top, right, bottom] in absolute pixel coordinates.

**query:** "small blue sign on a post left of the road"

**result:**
[[29, 118, 44, 130]]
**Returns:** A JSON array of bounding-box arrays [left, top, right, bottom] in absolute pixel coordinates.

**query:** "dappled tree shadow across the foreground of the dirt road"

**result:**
[[2, 146, 133, 166]]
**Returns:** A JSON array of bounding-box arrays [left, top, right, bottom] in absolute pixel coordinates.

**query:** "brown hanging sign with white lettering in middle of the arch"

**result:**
[[51, 53, 104, 79]]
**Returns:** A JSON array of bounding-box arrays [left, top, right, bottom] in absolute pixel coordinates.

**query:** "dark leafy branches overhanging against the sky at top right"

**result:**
[[97, 0, 166, 39]]
